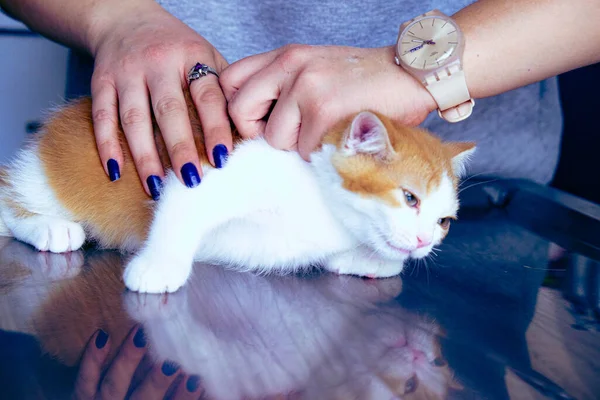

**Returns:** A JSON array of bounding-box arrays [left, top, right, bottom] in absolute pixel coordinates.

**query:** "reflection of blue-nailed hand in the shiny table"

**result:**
[[72, 326, 203, 400]]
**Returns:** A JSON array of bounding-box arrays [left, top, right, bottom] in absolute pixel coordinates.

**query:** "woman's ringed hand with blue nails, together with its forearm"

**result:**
[[1, 0, 233, 200]]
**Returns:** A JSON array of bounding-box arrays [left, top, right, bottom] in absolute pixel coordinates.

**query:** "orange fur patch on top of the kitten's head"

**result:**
[[323, 113, 465, 206]]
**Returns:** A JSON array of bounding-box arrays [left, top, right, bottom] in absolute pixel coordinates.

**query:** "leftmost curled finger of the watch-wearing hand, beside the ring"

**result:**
[[228, 64, 286, 138]]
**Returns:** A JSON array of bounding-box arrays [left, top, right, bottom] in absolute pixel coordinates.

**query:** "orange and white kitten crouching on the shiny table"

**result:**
[[0, 92, 475, 293]]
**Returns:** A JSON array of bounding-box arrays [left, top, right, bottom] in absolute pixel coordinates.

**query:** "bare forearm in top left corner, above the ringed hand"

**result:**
[[0, 0, 158, 53]]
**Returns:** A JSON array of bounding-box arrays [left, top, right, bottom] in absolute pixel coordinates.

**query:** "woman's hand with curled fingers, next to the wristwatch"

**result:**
[[220, 45, 437, 159]]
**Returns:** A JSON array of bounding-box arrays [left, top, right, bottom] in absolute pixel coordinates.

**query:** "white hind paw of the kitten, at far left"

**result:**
[[17, 216, 85, 253]]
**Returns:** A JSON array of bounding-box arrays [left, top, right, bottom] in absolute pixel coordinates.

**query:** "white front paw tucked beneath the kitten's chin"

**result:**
[[325, 251, 404, 278]]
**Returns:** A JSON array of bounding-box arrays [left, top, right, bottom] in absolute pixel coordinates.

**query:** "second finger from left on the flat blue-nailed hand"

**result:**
[[118, 76, 164, 196]]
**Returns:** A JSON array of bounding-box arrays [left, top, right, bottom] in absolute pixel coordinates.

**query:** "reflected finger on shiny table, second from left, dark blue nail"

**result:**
[[100, 326, 146, 399]]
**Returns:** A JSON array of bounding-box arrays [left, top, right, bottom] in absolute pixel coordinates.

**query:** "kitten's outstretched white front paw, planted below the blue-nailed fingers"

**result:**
[[123, 251, 192, 293]]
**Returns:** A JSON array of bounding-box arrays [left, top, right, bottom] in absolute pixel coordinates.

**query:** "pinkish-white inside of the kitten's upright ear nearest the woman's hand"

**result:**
[[342, 111, 395, 161]]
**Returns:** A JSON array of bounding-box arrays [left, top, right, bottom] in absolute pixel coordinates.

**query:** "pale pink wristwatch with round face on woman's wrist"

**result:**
[[395, 10, 475, 122]]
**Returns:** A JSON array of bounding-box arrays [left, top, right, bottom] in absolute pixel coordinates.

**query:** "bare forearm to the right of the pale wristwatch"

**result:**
[[453, 0, 600, 98]]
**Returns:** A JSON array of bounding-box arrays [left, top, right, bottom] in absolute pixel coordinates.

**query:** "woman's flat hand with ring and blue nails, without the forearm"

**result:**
[[89, 2, 232, 197]]
